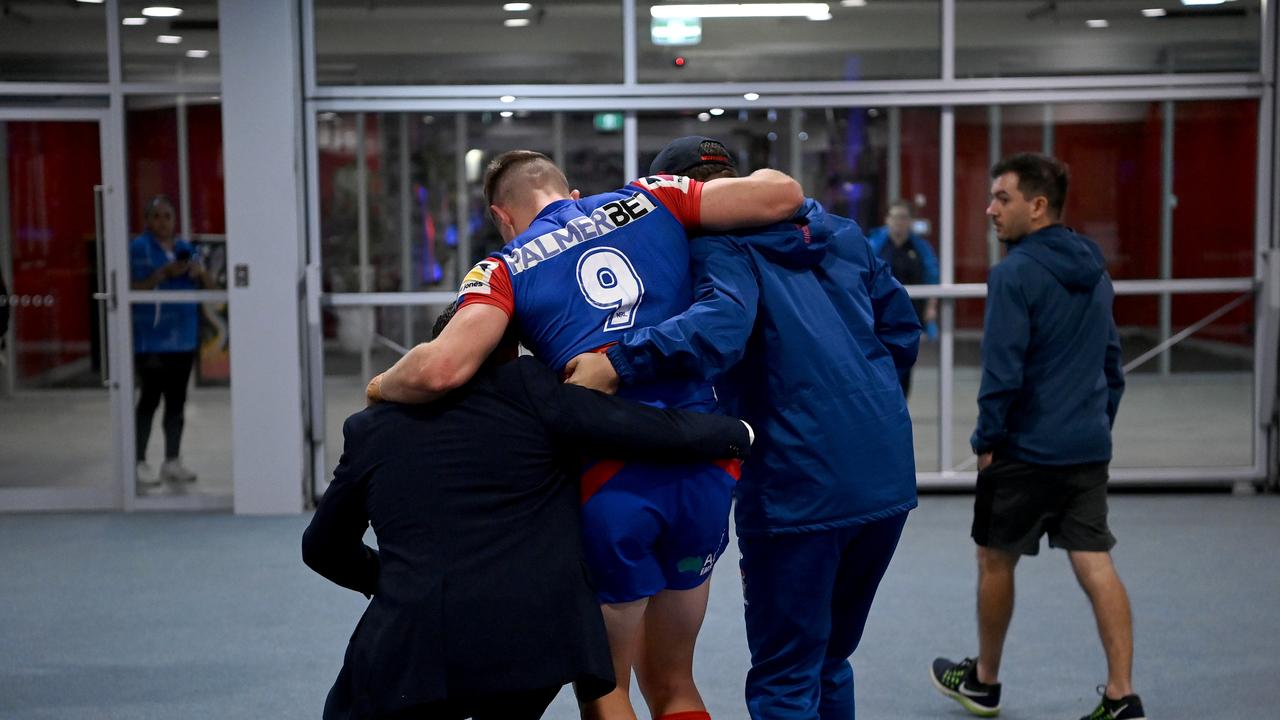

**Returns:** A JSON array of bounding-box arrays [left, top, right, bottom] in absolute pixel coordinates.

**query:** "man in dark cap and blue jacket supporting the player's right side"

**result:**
[[567, 137, 920, 720]]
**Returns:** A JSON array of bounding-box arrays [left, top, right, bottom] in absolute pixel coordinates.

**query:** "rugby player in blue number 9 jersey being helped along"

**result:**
[[369, 143, 804, 720]]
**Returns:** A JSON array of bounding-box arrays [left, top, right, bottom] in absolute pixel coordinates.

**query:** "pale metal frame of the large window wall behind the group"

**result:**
[[301, 0, 1280, 487]]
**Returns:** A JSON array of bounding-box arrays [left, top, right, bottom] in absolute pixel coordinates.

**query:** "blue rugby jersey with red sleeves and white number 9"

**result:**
[[458, 176, 716, 410]]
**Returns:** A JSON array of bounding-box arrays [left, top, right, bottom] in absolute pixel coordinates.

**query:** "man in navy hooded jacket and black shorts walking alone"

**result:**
[[931, 154, 1144, 720]]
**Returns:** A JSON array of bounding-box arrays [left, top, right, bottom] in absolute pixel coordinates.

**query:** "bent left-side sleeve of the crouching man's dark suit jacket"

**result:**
[[302, 415, 379, 597]]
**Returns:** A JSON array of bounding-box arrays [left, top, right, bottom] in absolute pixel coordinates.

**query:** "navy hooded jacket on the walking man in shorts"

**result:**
[[969, 225, 1124, 465]]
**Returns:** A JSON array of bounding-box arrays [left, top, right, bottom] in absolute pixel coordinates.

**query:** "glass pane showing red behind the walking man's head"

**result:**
[[956, 100, 1257, 282]]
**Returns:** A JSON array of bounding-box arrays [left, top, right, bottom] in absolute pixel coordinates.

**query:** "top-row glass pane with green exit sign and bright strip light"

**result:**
[[636, 0, 942, 83]]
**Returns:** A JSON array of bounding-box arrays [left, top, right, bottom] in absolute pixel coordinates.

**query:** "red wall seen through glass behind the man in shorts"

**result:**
[[952, 100, 1257, 342]]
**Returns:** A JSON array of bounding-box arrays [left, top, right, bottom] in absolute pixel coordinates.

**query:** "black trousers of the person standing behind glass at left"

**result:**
[[133, 351, 196, 462]]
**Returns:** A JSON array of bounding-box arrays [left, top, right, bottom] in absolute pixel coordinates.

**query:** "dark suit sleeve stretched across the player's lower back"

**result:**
[[517, 359, 750, 462]]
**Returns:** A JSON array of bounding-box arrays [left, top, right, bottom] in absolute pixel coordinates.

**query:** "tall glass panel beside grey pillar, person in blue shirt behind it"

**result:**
[[125, 95, 232, 497]]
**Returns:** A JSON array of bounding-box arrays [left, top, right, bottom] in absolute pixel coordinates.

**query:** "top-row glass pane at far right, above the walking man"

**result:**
[[956, 0, 1262, 77]]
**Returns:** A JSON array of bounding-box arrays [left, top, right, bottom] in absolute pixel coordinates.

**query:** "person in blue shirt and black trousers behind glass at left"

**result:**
[[129, 195, 214, 491]]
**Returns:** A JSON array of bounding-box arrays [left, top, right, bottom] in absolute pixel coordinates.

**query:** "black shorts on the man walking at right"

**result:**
[[972, 456, 1116, 555]]
